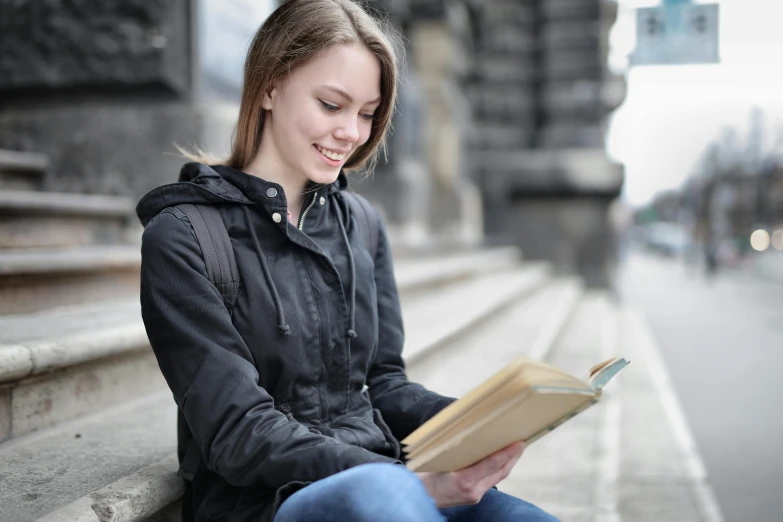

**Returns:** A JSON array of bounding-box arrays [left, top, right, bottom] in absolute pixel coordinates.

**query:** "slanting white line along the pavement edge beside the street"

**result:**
[[623, 309, 724, 522]]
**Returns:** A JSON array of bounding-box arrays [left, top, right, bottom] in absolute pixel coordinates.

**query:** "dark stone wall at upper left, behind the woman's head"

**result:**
[[0, 0, 263, 197]]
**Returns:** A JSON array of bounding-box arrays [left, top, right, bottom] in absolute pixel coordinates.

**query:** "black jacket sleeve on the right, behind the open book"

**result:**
[[367, 210, 455, 440]]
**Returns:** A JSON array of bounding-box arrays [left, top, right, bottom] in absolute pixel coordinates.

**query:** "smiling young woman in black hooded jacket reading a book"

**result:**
[[137, 0, 554, 522]]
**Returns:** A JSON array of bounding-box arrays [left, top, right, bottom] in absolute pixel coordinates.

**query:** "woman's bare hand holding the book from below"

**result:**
[[416, 442, 525, 508]]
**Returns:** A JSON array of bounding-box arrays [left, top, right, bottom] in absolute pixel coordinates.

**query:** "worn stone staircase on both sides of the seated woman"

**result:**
[[0, 148, 718, 522]]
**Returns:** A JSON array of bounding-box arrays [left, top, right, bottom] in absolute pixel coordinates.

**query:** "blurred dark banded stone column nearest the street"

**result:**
[[466, 0, 624, 286]]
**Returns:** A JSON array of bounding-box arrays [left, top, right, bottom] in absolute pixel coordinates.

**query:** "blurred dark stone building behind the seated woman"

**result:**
[[0, 0, 625, 285]]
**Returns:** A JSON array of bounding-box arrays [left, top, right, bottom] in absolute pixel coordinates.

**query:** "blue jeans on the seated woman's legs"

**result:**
[[274, 464, 557, 522]]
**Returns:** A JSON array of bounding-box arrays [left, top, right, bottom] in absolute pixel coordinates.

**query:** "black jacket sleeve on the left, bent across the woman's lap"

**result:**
[[141, 211, 398, 489]]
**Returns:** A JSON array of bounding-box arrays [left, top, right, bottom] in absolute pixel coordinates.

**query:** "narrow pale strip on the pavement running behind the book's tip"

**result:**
[[594, 296, 623, 522]]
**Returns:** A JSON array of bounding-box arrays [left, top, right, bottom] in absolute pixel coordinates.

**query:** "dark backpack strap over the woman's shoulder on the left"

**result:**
[[177, 204, 239, 481]]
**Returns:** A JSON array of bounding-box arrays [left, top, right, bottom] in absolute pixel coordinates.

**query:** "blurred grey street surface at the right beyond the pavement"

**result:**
[[618, 253, 783, 522]]
